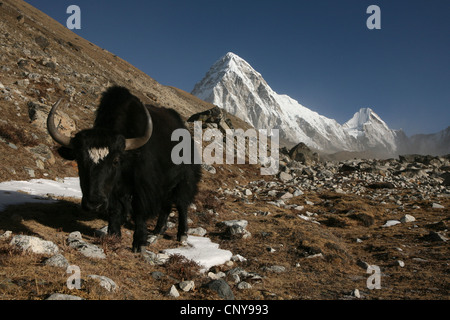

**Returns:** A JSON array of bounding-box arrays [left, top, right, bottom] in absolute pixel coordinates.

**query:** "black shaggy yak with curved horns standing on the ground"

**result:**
[[47, 86, 201, 252]]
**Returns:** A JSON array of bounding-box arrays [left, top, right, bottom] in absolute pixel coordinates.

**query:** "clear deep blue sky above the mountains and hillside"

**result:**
[[26, 0, 450, 135]]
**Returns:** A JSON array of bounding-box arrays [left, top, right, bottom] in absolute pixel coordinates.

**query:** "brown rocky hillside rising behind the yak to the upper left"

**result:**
[[0, 0, 248, 181]]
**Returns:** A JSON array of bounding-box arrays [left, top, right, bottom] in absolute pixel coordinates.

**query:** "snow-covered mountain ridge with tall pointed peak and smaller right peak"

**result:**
[[191, 52, 444, 155]]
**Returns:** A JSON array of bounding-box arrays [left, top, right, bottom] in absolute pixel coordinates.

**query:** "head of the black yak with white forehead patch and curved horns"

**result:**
[[47, 99, 153, 211]]
